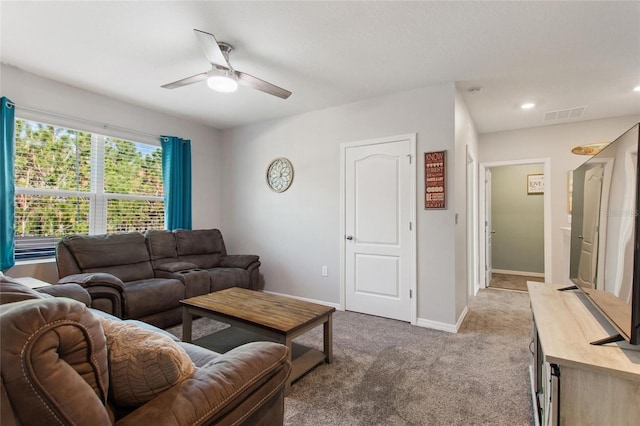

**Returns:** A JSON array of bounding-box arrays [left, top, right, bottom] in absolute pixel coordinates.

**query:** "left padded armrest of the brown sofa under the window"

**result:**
[[56, 272, 125, 318]]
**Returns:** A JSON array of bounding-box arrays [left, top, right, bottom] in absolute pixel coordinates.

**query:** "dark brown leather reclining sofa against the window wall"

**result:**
[[56, 229, 260, 328]]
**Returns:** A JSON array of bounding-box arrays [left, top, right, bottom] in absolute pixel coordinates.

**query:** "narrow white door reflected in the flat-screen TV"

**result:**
[[578, 165, 604, 288]]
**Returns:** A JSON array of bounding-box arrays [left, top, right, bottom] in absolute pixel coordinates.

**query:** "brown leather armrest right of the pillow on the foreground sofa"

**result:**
[[117, 342, 291, 425]]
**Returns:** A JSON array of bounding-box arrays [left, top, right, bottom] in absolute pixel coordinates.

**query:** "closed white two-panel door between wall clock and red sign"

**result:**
[[344, 138, 415, 321]]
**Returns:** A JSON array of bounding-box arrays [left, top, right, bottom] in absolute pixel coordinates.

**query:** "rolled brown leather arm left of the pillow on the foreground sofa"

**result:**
[[0, 298, 111, 425]]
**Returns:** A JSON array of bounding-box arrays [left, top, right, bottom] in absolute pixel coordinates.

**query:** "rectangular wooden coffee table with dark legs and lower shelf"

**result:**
[[180, 287, 336, 393]]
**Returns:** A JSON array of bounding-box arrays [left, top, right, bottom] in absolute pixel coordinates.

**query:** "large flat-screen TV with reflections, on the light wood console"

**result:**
[[569, 123, 640, 345]]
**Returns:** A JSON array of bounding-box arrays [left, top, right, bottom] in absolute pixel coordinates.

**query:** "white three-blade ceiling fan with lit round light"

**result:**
[[161, 29, 291, 99]]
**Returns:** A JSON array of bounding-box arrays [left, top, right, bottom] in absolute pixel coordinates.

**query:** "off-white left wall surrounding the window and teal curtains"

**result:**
[[0, 65, 222, 281]]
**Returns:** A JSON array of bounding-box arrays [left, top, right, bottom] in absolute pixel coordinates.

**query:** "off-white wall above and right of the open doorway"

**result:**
[[479, 116, 640, 284]]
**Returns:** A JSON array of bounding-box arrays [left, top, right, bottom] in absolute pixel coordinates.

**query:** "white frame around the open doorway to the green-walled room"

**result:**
[[478, 158, 553, 288]]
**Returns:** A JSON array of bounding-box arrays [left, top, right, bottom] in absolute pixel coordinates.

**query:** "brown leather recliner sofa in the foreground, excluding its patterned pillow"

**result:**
[[0, 276, 291, 426]]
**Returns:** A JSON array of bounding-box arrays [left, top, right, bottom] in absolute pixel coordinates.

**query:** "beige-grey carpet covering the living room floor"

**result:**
[[172, 289, 533, 426]]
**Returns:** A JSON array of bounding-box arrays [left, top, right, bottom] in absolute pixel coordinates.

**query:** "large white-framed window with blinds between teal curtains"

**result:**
[[15, 119, 164, 259]]
